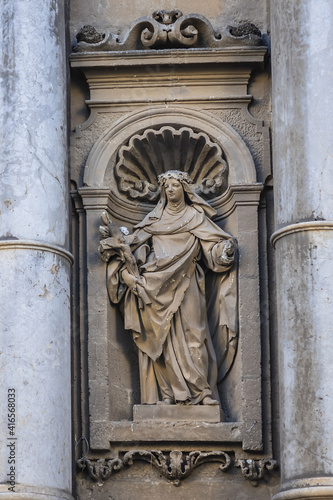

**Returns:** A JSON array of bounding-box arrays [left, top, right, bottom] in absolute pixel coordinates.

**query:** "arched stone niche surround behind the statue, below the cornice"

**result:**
[[78, 106, 262, 450]]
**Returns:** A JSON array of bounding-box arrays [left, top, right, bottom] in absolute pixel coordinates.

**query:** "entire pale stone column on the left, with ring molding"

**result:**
[[0, 0, 72, 500]]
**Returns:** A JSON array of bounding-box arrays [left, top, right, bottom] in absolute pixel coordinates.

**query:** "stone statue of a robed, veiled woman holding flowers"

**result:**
[[100, 170, 237, 405]]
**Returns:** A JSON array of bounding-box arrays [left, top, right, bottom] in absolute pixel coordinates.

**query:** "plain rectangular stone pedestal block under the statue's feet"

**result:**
[[133, 405, 225, 423]]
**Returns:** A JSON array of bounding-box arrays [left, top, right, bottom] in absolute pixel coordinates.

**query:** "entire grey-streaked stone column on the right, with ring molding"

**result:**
[[271, 0, 333, 500]]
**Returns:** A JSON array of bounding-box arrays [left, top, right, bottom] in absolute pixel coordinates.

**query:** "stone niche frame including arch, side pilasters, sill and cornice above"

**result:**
[[71, 46, 267, 458]]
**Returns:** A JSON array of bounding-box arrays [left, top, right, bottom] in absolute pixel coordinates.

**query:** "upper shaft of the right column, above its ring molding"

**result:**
[[272, 0, 333, 225]]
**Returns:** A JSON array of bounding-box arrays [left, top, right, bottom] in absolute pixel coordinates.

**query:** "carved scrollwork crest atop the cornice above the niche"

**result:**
[[73, 9, 262, 52]]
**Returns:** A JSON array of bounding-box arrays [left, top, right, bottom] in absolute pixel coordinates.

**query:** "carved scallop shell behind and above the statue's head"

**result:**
[[115, 126, 228, 202]]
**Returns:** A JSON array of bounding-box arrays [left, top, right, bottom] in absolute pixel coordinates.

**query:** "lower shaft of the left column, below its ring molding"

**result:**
[[0, 248, 71, 498]]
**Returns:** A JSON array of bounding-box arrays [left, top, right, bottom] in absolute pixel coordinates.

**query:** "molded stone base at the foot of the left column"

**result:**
[[0, 483, 74, 500]]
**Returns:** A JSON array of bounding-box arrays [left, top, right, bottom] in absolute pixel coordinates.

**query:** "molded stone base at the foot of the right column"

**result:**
[[273, 477, 333, 500]]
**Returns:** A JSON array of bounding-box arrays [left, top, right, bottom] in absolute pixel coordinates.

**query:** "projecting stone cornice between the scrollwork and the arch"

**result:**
[[71, 46, 267, 108]]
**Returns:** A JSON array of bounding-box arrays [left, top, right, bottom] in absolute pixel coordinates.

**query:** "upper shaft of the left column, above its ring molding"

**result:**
[[0, 0, 68, 246]]
